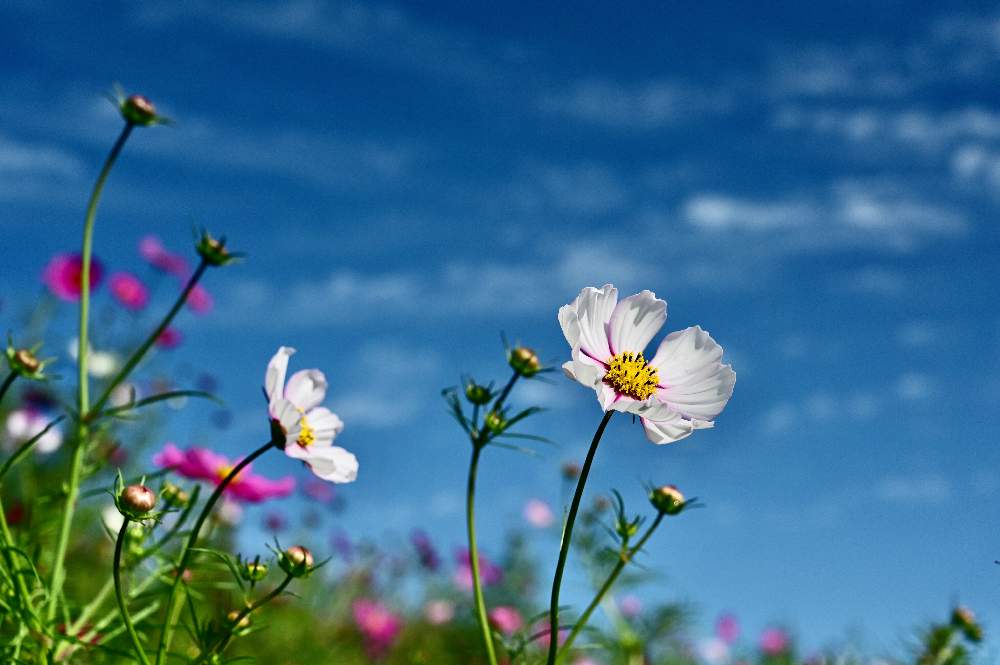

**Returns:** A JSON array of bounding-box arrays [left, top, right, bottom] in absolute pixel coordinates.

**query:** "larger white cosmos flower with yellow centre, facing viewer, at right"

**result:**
[[559, 284, 736, 443]]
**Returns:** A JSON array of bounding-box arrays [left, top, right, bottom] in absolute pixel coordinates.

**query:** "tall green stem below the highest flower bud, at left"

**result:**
[[46, 122, 134, 623]]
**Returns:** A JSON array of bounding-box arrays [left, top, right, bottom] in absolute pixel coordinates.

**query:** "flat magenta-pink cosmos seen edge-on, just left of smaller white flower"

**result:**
[[153, 443, 295, 503]]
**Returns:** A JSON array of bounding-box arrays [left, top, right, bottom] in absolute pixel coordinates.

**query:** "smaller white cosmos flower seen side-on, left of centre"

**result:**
[[264, 346, 358, 483]]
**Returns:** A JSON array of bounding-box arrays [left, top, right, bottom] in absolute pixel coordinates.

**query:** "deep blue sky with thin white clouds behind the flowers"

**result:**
[[0, 1, 1000, 650]]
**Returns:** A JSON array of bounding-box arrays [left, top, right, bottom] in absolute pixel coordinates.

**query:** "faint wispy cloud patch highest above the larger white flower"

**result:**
[[539, 79, 731, 130]]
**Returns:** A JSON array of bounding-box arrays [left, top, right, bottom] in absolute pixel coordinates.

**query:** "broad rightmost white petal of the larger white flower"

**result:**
[[650, 326, 736, 420]]
